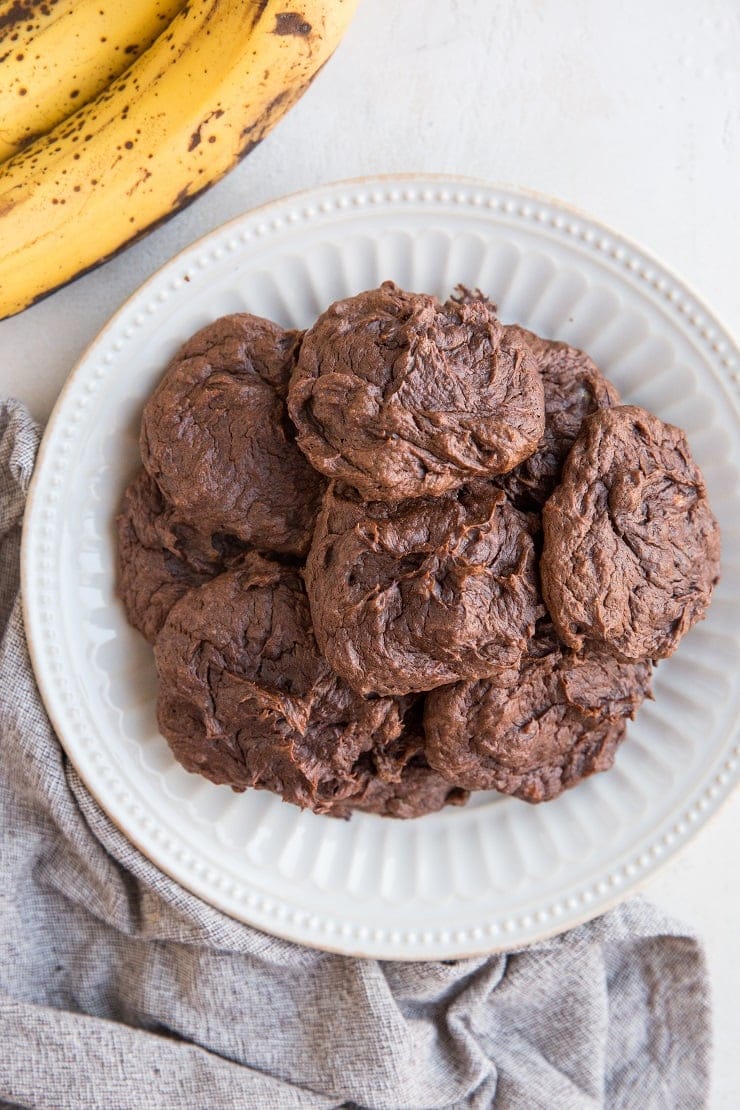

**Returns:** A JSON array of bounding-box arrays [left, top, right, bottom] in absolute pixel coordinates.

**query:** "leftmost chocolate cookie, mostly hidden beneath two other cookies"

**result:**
[[115, 471, 223, 643]]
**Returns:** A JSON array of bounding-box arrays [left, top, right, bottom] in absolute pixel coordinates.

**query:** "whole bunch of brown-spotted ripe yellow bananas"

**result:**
[[0, 0, 357, 319]]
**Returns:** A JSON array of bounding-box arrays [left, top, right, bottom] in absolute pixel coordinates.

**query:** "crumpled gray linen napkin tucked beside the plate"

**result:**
[[0, 402, 709, 1110]]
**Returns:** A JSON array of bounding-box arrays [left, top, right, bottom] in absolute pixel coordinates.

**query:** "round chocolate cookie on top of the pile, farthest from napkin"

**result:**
[[288, 282, 545, 501]]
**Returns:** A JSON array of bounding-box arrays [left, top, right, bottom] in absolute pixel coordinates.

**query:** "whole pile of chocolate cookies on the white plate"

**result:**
[[118, 282, 719, 817]]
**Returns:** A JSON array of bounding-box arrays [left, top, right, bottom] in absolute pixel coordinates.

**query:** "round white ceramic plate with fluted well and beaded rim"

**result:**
[[23, 178, 740, 959]]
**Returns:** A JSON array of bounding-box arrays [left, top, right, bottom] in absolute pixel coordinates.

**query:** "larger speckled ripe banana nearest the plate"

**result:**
[[0, 0, 357, 319]]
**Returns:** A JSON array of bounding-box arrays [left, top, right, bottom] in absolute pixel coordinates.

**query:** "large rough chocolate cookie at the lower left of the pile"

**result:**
[[154, 554, 455, 816]]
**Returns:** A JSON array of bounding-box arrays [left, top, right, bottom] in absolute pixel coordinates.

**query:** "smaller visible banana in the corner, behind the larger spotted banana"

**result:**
[[0, 0, 185, 162]]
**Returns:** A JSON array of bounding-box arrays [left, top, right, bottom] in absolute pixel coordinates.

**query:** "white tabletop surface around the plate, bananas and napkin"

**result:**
[[0, 0, 740, 1110]]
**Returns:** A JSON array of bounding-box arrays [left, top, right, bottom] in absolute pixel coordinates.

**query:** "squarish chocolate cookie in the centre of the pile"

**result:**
[[305, 483, 538, 694]]
